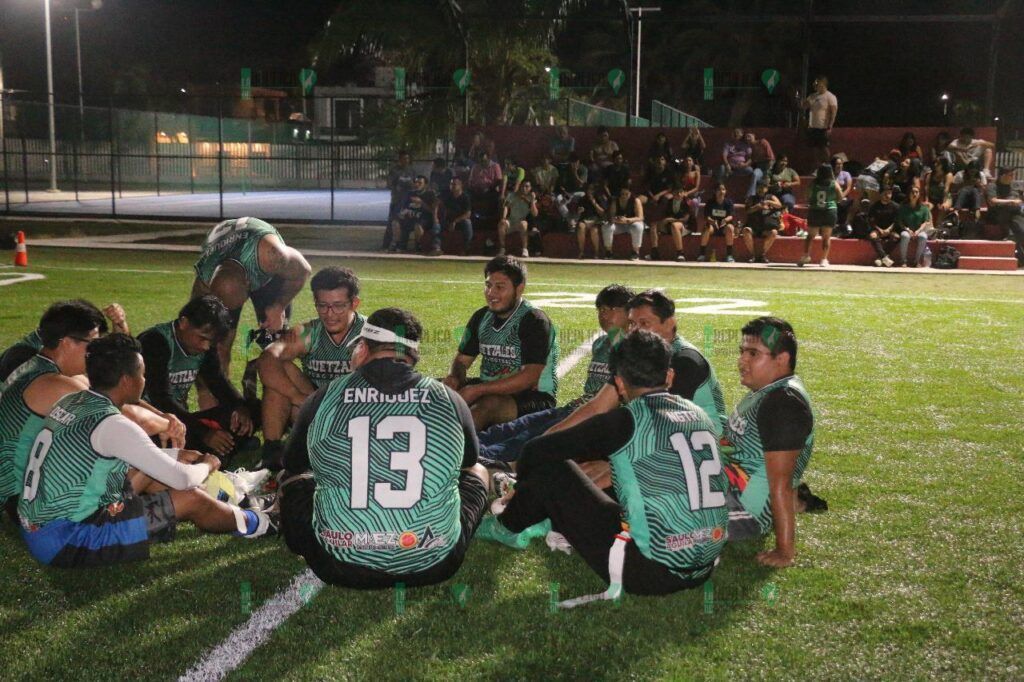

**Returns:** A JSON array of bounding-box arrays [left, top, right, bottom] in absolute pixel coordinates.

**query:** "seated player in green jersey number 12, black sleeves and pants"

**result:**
[[478, 331, 728, 605]]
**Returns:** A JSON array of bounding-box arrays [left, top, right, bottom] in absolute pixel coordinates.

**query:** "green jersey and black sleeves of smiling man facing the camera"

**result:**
[[459, 299, 558, 396]]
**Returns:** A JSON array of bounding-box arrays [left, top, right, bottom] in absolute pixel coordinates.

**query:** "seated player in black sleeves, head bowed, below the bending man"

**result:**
[[138, 296, 253, 458]]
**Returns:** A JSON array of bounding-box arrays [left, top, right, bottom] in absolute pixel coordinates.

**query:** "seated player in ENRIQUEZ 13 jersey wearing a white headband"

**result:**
[[281, 308, 487, 589]]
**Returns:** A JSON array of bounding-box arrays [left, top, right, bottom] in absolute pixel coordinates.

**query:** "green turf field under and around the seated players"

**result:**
[[0, 248, 1024, 679]]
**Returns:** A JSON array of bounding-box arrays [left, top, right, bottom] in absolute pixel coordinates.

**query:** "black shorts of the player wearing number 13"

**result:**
[[279, 471, 487, 590]]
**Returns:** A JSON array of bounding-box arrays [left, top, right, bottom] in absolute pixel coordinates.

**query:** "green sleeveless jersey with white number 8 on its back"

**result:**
[[17, 390, 128, 526]]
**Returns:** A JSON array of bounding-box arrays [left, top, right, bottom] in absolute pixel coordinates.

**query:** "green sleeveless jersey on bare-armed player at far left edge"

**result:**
[[0, 355, 60, 503]]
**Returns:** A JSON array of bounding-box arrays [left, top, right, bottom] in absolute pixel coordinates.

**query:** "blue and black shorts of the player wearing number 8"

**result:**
[[23, 491, 177, 568]]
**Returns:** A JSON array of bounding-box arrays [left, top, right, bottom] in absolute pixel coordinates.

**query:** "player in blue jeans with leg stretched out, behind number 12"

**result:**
[[480, 285, 634, 463]]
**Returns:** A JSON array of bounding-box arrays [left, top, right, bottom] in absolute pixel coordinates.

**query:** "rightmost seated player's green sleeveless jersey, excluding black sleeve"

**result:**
[[725, 376, 814, 534]]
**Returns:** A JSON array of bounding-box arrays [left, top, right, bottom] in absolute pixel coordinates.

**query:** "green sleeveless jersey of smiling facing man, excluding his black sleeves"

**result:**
[[477, 299, 558, 395]]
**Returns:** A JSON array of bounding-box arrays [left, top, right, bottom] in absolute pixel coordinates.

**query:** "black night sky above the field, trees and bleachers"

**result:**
[[0, 0, 1024, 129]]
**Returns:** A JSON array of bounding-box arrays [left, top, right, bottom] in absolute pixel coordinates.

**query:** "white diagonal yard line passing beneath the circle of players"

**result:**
[[178, 331, 601, 682]]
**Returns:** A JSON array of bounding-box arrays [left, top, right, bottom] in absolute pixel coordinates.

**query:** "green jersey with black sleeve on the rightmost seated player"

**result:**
[[723, 376, 814, 534]]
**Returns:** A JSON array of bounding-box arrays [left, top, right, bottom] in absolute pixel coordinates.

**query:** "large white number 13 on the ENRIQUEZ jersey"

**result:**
[[348, 417, 427, 509]]
